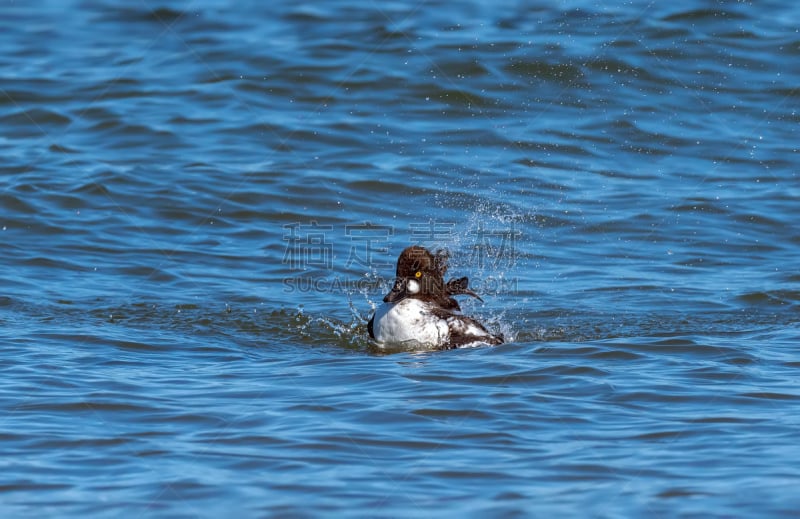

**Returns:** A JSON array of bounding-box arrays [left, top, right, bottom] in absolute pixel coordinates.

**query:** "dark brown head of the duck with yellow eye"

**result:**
[[383, 245, 450, 303]]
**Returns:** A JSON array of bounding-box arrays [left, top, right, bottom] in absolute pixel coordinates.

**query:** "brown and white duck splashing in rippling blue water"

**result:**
[[367, 245, 503, 350]]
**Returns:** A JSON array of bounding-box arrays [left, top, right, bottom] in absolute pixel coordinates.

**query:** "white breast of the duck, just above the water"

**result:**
[[372, 298, 450, 347]]
